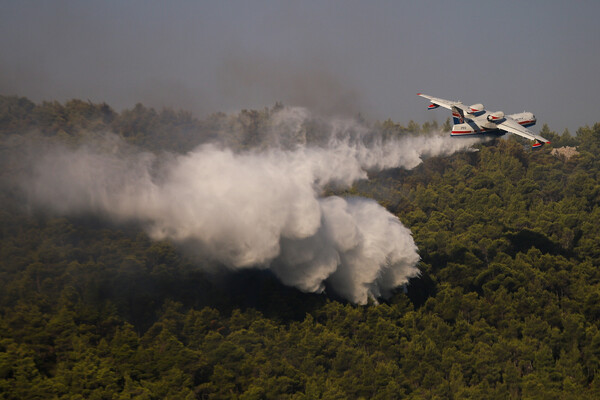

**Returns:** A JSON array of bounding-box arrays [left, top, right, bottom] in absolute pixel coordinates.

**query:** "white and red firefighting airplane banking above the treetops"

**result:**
[[417, 93, 550, 148]]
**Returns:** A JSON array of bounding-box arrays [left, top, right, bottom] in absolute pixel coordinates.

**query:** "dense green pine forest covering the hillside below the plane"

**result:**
[[0, 96, 600, 399]]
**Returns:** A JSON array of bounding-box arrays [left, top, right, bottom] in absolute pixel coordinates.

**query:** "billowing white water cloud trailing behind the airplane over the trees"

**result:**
[[18, 108, 477, 304]]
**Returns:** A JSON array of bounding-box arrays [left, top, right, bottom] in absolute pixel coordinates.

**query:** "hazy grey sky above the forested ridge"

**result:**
[[0, 0, 600, 133]]
